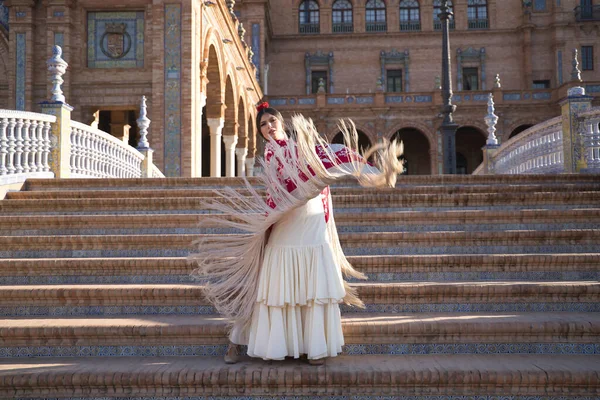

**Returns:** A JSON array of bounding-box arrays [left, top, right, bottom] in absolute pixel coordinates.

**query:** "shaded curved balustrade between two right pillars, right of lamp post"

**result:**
[[482, 117, 564, 174]]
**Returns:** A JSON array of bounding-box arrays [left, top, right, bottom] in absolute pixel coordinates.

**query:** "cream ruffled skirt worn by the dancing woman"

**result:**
[[248, 196, 346, 360]]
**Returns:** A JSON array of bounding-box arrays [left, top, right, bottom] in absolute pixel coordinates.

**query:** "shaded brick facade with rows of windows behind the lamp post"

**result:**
[[236, 0, 600, 174]]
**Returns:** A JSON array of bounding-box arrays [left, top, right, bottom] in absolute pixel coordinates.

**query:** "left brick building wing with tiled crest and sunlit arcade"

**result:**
[[0, 0, 262, 176]]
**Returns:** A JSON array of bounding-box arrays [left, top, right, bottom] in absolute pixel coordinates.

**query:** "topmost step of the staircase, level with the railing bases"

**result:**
[[23, 174, 600, 191]]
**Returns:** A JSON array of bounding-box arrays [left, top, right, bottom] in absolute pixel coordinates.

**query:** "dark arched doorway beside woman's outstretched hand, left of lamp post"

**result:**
[[392, 128, 431, 175]]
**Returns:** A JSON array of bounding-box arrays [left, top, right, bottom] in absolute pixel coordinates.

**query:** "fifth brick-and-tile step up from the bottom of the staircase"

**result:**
[[0, 229, 600, 258]]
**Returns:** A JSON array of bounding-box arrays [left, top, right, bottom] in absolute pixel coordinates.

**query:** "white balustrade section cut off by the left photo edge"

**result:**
[[0, 110, 56, 184]]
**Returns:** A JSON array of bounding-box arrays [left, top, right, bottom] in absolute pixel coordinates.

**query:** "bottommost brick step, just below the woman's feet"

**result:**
[[0, 354, 600, 400]]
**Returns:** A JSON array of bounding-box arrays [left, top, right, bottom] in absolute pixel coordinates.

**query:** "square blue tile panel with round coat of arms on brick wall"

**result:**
[[87, 11, 144, 68]]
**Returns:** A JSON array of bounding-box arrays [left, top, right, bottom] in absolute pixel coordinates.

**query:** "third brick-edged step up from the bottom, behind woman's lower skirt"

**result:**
[[0, 281, 600, 317]]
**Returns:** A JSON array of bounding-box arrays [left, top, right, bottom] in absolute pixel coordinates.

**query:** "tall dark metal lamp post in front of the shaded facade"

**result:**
[[439, 0, 458, 174]]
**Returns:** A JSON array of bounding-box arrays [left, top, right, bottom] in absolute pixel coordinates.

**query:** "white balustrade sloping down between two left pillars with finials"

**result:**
[[71, 121, 144, 178]]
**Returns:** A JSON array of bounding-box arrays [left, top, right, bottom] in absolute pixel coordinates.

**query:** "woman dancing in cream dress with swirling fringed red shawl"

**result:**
[[190, 103, 402, 365]]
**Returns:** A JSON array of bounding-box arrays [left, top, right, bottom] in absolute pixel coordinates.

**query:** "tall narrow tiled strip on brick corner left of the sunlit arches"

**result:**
[[164, 4, 181, 176]]
